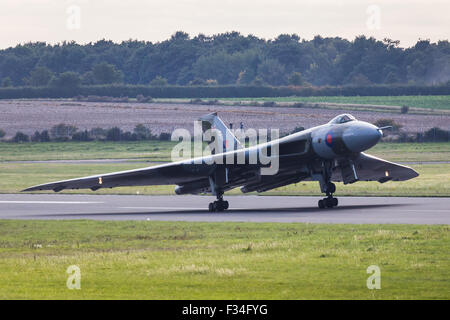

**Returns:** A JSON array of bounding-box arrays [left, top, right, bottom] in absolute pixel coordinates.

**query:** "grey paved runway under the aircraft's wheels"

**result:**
[[0, 194, 450, 224]]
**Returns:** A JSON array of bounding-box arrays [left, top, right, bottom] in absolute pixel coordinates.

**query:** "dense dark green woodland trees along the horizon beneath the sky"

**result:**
[[0, 31, 450, 88]]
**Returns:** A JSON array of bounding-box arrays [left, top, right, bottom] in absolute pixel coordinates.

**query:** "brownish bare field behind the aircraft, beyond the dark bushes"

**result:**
[[0, 100, 450, 137]]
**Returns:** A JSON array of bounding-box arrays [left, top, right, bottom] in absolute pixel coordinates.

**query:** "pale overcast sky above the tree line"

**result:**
[[0, 0, 450, 49]]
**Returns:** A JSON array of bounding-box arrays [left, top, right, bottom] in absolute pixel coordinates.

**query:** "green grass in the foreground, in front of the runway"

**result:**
[[0, 220, 450, 299]]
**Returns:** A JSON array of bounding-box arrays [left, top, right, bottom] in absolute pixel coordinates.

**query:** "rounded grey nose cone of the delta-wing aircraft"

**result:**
[[342, 121, 382, 152]]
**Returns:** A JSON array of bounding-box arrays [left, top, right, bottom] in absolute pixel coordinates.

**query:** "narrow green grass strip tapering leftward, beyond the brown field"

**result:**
[[220, 96, 450, 110]]
